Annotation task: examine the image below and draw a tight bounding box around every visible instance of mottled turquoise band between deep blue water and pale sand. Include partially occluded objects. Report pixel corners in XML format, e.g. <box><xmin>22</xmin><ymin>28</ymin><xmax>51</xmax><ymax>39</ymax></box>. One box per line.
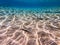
<box><xmin>0</xmin><ymin>6</ymin><xmax>60</xmax><ymax>15</ymax></box>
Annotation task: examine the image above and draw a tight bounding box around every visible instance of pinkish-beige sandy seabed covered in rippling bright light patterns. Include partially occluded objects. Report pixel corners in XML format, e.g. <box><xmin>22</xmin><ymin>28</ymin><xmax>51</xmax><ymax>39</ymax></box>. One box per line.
<box><xmin>0</xmin><ymin>7</ymin><xmax>60</xmax><ymax>45</ymax></box>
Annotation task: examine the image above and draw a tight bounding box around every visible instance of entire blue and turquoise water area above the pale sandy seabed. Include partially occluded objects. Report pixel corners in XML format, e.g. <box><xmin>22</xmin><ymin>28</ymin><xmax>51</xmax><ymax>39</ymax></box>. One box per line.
<box><xmin>0</xmin><ymin>0</ymin><xmax>60</xmax><ymax>13</ymax></box>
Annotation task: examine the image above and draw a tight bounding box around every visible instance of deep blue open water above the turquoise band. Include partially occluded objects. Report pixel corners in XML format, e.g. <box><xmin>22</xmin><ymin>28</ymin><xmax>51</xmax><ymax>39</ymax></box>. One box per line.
<box><xmin>0</xmin><ymin>0</ymin><xmax>60</xmax><ymax>8</ymax></box>
